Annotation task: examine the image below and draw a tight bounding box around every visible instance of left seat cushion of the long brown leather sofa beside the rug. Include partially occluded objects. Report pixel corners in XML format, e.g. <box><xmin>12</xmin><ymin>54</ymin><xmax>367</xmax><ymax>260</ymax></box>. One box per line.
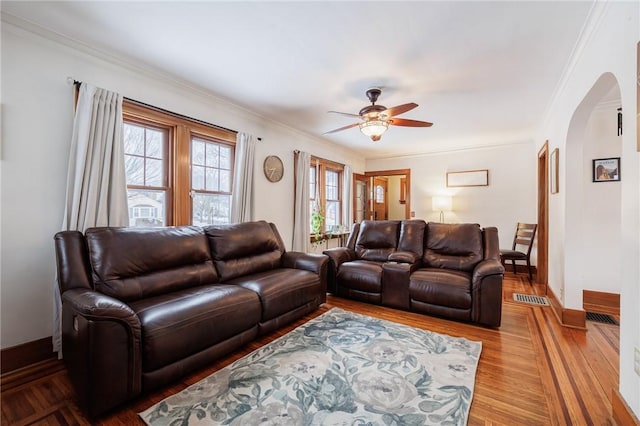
<box><xmin>130</xmin><ymin>284</ymin><xmax>261</xmax><ymax>372</ymax></box>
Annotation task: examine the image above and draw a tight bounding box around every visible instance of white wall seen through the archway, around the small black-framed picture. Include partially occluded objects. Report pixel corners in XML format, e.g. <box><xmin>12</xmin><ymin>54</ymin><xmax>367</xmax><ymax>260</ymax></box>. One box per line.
<box><xmin>564</xmin><ymin>73</ymin><xmax>624</xmax><ymax>309</ymax></box>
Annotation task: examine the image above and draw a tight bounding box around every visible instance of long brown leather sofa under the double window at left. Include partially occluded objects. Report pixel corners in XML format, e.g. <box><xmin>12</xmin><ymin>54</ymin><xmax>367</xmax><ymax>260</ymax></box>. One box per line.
<box><xmin>55</xmin><ymin>221</ymin><xmax>328</xmax><ymax>418</ymax></box>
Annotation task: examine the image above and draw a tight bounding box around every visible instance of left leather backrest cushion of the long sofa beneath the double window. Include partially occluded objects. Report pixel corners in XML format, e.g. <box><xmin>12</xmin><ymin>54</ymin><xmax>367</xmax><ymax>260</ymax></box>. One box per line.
<box><xmin>85</xmin><ymin>226</ymin><xmax>218</xmax><ymax>301</ymax></box>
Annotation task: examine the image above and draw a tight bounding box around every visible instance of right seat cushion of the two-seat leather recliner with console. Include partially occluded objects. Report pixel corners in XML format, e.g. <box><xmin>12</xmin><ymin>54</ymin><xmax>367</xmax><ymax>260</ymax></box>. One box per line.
<box><xmin>409</xmin><ymin>268</ymin><xmax>471</xmax><ymax>309</ymax></box>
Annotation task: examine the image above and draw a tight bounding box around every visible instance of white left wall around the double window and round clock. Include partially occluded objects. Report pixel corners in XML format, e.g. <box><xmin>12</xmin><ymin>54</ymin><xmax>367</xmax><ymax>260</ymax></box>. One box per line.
<box><xmin>0</xmin><ymin>17</ymin><xmax>364</xmax><ymax>348</ymax></box>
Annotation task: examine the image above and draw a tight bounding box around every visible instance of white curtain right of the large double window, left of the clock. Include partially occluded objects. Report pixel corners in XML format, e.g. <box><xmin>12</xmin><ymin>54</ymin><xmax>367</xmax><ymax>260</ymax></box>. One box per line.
<box><xmin>231</xmin><ymin>132</ymin><xmax>256</xmax><ymax>223</ymax></box>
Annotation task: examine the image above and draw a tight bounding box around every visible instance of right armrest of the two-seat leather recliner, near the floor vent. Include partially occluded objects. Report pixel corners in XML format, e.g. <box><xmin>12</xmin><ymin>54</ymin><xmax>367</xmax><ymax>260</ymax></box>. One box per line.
<box><xmin>471</xmin><ymin>259</ymin><xmax>504</xmax><ymax>327</ymax></box>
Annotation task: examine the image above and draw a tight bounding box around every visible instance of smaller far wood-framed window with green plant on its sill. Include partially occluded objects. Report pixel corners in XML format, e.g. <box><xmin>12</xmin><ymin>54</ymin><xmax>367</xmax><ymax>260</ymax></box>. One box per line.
<box><xmin>309</xmin><ymin>158</ymin><xmax>344</xmax><ymax>232</ymax></box>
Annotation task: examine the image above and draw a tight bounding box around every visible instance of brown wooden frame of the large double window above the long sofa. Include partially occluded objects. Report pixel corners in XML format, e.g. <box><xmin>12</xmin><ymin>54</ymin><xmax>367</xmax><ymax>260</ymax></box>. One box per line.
<box><xmin>122</xmin><ymin>99</ymin><xmax>237</xmax><ymax>226</ymax></box>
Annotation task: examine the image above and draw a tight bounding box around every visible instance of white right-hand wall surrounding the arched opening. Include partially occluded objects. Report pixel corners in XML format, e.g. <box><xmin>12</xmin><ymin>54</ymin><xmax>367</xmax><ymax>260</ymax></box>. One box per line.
<box><xmin>531</xmin><ymin>2</ymin><xmax>640</xmax><ymax>417</ymax></box>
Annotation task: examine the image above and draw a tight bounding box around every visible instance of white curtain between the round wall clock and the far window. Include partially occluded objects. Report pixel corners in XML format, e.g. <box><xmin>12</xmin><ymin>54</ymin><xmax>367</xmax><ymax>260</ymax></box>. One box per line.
<box><xmin>291</xmin><ymin>151</ymin><xmax>311</xmax><ymax>252</ymax></box>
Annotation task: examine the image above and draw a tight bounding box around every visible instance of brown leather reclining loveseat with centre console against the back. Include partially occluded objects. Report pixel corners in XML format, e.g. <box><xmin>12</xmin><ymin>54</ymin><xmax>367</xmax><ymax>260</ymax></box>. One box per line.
<box><xmin>324</xmin><ymin>220</ymin><xmax>504</xmax><ymax>327</ymax></box>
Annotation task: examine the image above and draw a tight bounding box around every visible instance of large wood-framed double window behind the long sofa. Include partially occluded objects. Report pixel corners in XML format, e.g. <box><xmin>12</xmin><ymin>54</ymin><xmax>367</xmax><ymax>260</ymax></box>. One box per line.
<box><xmin>123</xmin><ymin>100</ymin><xmax>236</xmax><ymax>226</ymax></box>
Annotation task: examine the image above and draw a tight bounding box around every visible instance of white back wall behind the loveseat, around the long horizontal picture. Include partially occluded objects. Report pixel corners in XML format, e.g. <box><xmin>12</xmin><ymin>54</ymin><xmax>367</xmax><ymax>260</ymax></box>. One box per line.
<box><xmin>366</xmin><ymin>142</ymin><xmax>537</xmax><ymax>256</ymax></box>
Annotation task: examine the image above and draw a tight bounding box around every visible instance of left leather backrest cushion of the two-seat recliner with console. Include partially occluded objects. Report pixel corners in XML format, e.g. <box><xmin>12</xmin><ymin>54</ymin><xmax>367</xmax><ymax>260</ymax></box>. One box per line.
<box><xmin>355</xmin><ymin>220</ymin><xmax>400</xmax><ymax>262</ymax></box>
